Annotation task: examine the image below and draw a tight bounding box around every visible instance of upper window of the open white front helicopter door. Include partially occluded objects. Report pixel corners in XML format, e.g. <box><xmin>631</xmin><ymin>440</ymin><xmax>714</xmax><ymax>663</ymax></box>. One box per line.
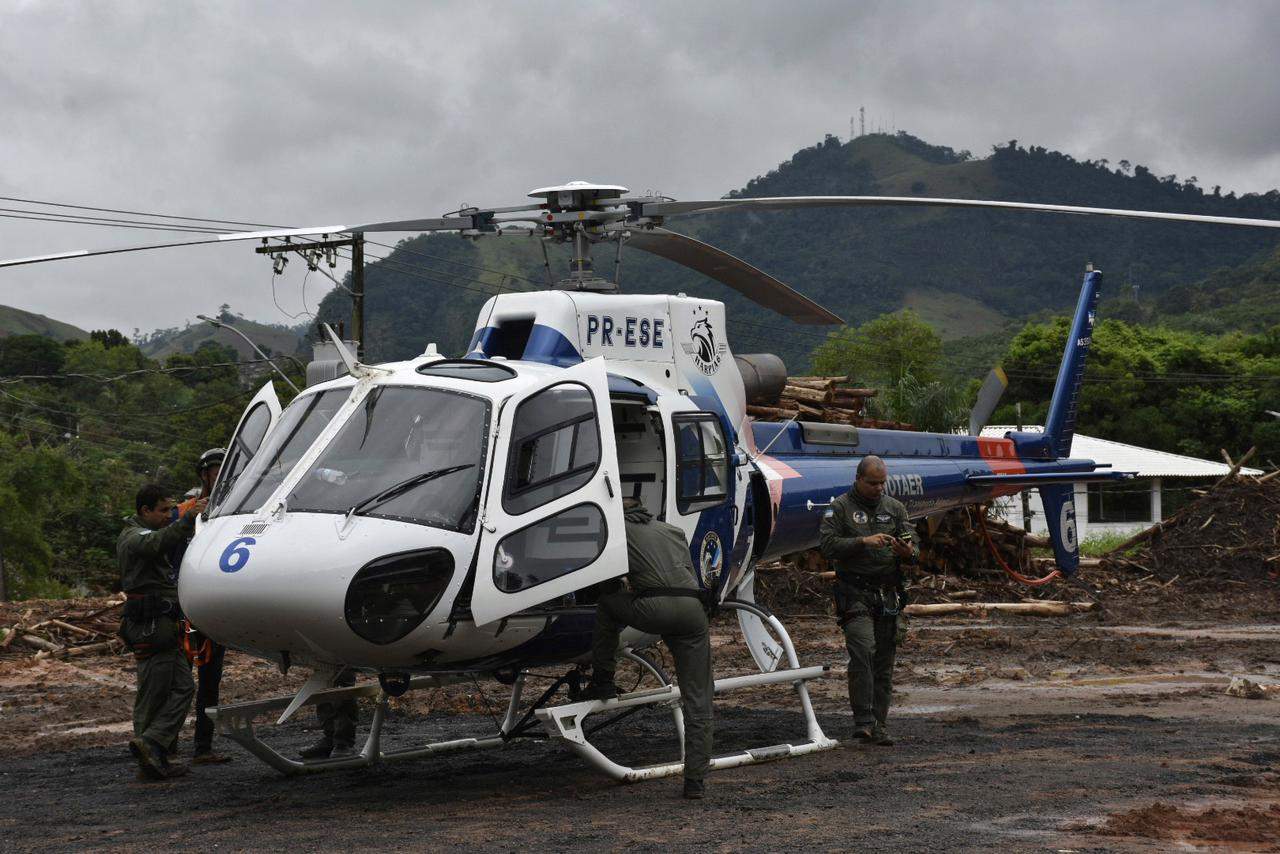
<box><xmin>502</xmin><ymin>383</ymin><xmax>600</xmax><ymax>516</ymax></box>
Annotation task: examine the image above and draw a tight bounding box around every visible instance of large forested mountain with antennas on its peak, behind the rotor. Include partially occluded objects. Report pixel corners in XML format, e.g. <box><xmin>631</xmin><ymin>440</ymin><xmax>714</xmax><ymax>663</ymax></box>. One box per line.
<box><xmin>312</xmin><ymin>133</ymin><xmax>1280</xmax><ymax>371</ymax></box>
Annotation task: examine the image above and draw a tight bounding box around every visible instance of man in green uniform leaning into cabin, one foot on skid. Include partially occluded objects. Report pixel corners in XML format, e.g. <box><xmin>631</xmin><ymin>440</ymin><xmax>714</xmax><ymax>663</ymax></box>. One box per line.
<box><xmin>581</xmin><ymin>498</ymin><xmax>714</xmax><ymax>799</ymax></box>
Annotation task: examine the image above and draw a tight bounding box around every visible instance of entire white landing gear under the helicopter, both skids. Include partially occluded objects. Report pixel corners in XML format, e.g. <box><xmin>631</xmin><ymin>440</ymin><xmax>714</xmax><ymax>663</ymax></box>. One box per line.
<box><xmin>209</xmin><ymin>600</ymin><xmax>837</xmax><ymax>782</ymax></box>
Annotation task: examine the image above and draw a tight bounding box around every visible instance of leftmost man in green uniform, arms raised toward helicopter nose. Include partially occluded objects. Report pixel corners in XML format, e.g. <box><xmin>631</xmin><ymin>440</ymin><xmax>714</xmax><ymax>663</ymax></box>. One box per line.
<box><xmin>115</xmin><ymin>484</ymin><xmax>206</xmax><ymax>780</ymax></box>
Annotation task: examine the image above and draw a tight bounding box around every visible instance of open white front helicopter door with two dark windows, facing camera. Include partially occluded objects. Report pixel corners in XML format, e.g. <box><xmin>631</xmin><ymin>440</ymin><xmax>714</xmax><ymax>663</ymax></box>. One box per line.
<box><xmin>471</xmin><ymin>359</ymin><xmax>627</xmax><ymax>625</ymax></box>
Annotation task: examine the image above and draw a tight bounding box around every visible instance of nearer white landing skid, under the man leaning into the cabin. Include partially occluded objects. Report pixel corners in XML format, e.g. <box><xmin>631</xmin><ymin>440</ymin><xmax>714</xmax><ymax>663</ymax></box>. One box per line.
<box><xmin>535</xmin><ymin>599</ymin><xmax>840</xmax><ymax>782</ymax></box>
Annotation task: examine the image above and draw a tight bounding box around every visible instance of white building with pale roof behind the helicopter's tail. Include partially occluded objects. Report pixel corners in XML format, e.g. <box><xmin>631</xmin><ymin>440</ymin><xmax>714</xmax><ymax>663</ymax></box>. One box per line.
<box><xmin>982</xmin><ymin>426</ymin><xmax>1262</xmax><ymax>540</ymax></box>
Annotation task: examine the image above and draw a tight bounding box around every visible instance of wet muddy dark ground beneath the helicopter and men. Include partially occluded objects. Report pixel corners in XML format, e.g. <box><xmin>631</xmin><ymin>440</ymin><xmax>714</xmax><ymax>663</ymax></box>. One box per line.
<box><xmin>0</xmin><ymin>593</ymin><xmax>1280</xmax><ymax>851</ymax></box>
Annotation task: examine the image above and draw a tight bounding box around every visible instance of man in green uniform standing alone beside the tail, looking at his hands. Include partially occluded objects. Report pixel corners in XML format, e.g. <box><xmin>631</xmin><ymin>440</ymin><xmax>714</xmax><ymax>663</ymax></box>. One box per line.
<box><xmin>819</xmin><ymin>456</ymin><xmax>918</xmax><ymax>746</ymax></box>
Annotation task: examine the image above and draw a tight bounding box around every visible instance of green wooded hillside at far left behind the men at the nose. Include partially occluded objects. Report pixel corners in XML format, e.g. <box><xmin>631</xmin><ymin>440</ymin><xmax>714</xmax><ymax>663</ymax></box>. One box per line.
<box><xmin>0</xmin><ymin>329</ymin><xmax>289</xmax><ymax>598</ymax></box>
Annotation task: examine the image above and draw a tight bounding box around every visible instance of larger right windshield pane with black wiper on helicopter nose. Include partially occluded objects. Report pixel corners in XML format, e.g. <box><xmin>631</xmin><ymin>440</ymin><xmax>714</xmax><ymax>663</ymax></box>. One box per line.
<box><xmin>288</xmin><ymin>385</ymin><xmax>489</xmax><ymax>531</ymax></box>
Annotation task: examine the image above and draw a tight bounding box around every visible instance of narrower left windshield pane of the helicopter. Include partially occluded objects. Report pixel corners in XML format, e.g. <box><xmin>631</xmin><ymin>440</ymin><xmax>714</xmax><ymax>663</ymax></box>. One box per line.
<box><xmin>214</xmin><ymin>388</ymin><xmax>351</xmax><ymax>516</ymax></box>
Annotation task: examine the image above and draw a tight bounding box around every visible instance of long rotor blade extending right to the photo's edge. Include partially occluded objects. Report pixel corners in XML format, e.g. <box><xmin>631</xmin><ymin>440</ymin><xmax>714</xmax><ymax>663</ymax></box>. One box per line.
<box><xmin>643</xmin><ymin>196</ymin><xmax>1280</xmax><ymax>228</ymax></box>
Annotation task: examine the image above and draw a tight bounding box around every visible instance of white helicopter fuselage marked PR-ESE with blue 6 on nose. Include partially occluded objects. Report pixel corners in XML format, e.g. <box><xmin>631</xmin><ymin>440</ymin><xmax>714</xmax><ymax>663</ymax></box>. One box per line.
<box><xmin>179</xmin><ymin>291</ymin><xmax>755</xmax><ymax>672</ymax></box>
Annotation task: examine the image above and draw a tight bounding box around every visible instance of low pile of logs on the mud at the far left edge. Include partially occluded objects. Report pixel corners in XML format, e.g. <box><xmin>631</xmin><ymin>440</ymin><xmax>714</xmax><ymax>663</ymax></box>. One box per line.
<box><xmin>0</xmin><ymin>594</ymin><xmax>124</xmax><ymax>658</ymax></box>
